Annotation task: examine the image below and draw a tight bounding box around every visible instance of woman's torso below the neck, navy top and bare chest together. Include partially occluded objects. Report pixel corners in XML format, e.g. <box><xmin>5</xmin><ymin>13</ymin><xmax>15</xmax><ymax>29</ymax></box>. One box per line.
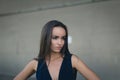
<box><xmin>36</xmin><ymin>53</ymin><xmax>77</xmax><ymax>80</ymax></box>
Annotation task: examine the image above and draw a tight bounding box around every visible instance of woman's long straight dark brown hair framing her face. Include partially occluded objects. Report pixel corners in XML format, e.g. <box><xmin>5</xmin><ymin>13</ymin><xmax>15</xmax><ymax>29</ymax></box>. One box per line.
<box><xmin>38</xmin><ymin>20</ymin><xmax>69</xmax><ymax>59</ymax></box>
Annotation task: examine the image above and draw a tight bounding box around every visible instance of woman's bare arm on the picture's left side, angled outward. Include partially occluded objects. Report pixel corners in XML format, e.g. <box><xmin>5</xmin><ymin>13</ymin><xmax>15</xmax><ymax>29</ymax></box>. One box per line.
<box><xmin>14</xmin><ymin>60</ymin><xmax>38</xmax><ymax>80</ymax></box>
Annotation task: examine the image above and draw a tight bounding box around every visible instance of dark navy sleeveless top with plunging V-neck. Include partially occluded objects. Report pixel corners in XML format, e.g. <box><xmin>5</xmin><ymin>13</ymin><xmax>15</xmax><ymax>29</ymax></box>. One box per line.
<box><xmin>36</xmin><ymin>54</ymin><xmax>77</xmax><ymax>80</ymax></box>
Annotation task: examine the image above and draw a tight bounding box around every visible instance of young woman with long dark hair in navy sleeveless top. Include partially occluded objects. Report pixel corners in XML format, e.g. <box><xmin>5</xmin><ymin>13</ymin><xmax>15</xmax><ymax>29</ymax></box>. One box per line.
<box><xmin>14</xmin><ymin>20</ymin><xmax>100</xmax><ymax>80</ymax></box>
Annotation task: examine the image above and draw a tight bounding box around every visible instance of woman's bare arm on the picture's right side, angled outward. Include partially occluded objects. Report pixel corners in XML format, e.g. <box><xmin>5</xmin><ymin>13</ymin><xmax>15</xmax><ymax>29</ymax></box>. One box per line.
<box><xmin>72</xmin><ymin>55</ymin><xmax>100</xmax><ymax>80</ymax></box>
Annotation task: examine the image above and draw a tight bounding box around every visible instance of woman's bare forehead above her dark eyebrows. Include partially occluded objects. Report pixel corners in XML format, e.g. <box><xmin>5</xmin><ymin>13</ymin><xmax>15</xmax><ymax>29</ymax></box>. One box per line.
<box><xmin>52</xmin><ymin>26</ymin><xmax>66</xmax><ymax>36</ymax></box>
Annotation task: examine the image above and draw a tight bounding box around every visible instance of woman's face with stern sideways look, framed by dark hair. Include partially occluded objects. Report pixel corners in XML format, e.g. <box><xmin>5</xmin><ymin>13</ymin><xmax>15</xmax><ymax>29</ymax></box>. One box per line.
<box><xmin>51</xmin><ymin>26</ymin><xmax>66</xmax><ymax>53</ymax></box>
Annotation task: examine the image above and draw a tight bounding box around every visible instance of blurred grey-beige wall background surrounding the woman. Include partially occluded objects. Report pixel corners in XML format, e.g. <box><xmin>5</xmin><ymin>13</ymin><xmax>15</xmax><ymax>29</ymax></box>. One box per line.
<box><xmin>0</xmin><ymin>0</ymin><xmax>120</xmax><ymax>80</ymax></box>
